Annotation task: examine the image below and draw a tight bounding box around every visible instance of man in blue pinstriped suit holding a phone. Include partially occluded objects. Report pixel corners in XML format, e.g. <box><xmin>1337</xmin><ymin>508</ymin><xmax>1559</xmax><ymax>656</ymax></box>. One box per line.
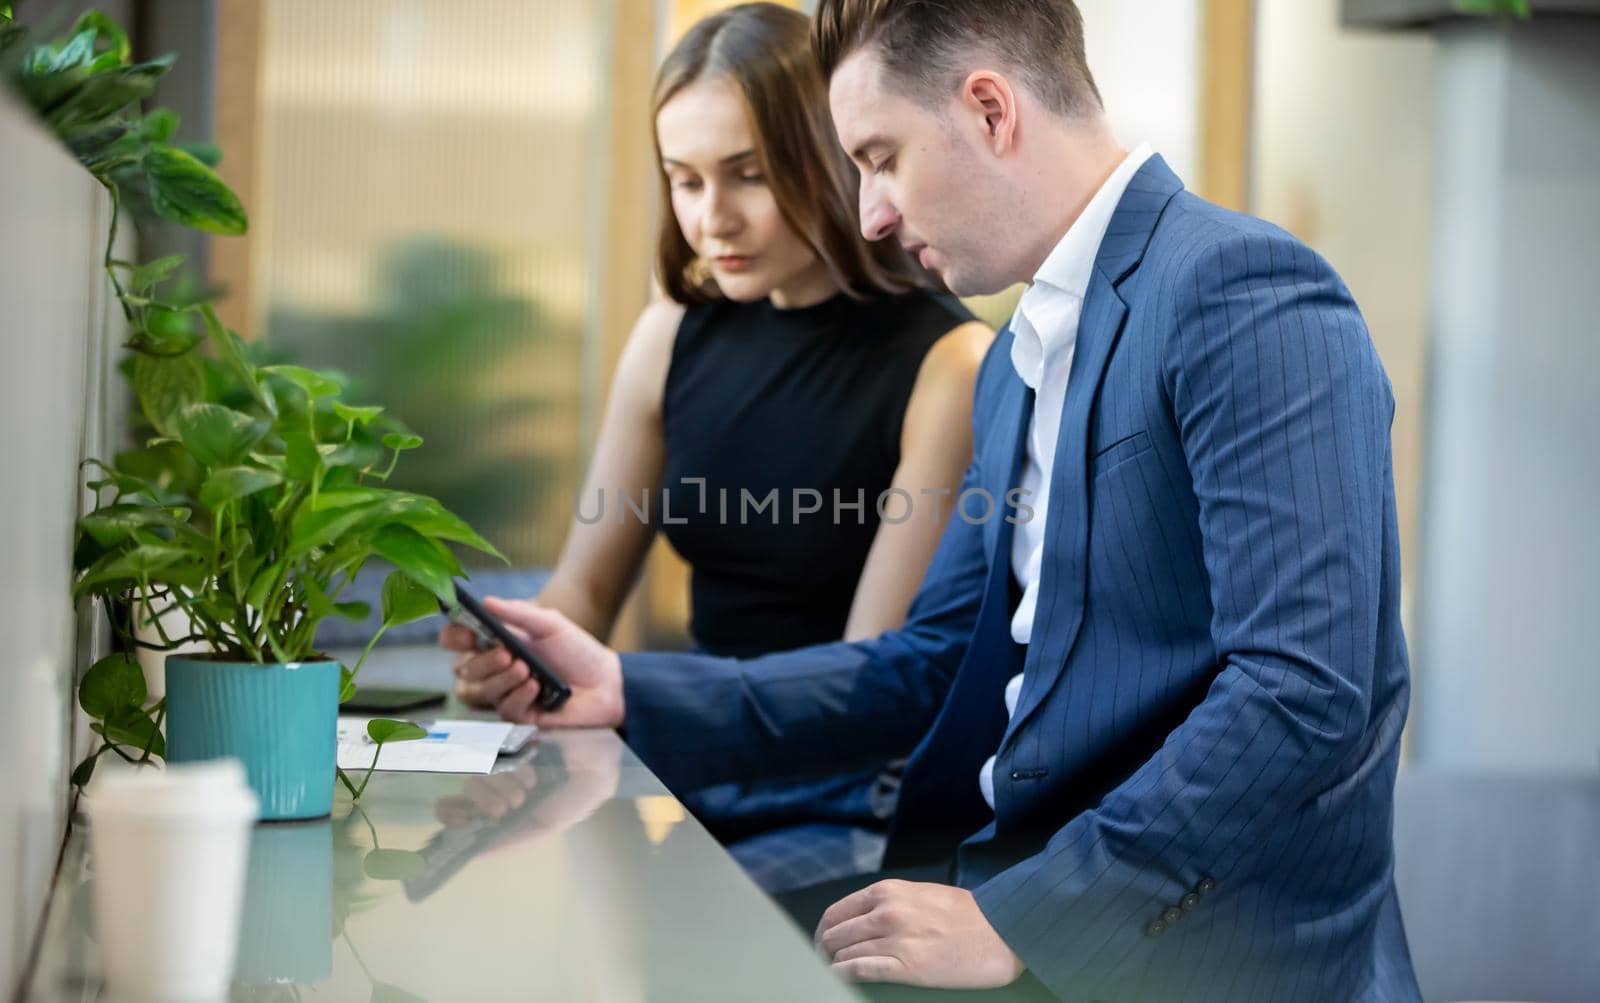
<box><xmin>451</xmin><ymin>0</ymin><xmax>1418</xmax><ymax>1003</ymax></box>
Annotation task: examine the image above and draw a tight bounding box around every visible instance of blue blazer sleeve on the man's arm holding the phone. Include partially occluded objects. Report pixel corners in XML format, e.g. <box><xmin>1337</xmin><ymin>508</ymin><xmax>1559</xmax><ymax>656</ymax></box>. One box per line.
<box><xmin>622</xmin><ymin>338</ymin><xmax>1010</xmax><ymax>790</ymax></box>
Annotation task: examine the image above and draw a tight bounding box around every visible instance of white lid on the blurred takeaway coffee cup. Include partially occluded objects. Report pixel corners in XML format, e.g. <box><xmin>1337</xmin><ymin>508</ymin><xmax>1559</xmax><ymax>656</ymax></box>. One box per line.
<box><xmin>83</xmin><ymin>760</ymin><xmax>261</xmax><ymax>822</ymax></box>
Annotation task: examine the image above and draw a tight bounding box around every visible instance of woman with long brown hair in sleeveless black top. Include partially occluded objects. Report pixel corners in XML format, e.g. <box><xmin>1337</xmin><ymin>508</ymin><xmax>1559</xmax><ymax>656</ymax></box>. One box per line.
<box><xmin>442</xmin><ymin>3</ymin><xmax>992</xmax><ymax>891</ymax></box>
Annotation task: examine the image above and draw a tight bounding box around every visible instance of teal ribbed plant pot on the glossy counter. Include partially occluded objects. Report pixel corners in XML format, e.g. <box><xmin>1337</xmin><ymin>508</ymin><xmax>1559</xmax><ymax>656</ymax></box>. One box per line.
<box><xmin>166</xmin><ymin>656</ymin><xmax>339</xmax><ymax>822</ymax></box>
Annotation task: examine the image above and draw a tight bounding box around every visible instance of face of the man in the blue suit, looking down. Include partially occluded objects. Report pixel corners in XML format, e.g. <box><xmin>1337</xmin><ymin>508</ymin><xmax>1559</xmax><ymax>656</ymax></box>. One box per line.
<box><xmin>829</xmin><ymin>46</ymin><xmax>1014</xmax><ymax>296</ymax></box>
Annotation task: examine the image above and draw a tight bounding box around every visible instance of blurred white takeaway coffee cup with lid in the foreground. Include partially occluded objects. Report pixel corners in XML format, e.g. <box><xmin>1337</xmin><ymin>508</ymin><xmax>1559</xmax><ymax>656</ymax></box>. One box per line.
<box><xmin>83</xmin><ymin>760</ymin><xmax>261</xmax><ymax>1000</ymax></box>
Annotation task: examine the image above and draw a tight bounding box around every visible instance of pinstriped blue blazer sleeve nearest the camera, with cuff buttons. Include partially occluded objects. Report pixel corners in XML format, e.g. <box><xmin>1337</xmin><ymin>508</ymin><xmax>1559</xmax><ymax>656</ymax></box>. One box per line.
<box><xmin>974</xmin><ymin>227</ymin><xmax>1394</xmax><ymax>995</ymax></box>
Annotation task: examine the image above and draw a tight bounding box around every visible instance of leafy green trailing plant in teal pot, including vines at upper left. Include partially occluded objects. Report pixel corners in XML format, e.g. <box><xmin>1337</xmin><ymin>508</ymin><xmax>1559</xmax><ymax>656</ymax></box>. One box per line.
<box><xmin>0</xmin><ymin>3</ymin><xmax>498</xmax><ymax>819</ymax></box>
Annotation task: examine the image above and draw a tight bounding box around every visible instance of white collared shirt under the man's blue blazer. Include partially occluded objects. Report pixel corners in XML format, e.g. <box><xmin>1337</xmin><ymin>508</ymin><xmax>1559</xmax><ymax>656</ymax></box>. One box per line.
<box><xmin>978</xmin><ymin>144</ymin><xmax>1152</xmax><ymax>808</ymax></box>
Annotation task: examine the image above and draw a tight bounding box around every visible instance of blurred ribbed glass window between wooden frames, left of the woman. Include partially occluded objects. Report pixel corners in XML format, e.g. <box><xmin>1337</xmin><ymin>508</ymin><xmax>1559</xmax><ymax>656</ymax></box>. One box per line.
<box><xmin>253</xmin><ymin>0</ymin><xmax>614</xmax><ymax>566</ymax></box>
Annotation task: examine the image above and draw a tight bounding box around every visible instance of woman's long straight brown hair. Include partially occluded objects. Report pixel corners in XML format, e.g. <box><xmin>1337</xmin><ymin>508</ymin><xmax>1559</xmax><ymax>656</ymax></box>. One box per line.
<box><xmin>654</xmin><ymin>3</ymin><xmax>938</xmax><ymax>304</ymax></box>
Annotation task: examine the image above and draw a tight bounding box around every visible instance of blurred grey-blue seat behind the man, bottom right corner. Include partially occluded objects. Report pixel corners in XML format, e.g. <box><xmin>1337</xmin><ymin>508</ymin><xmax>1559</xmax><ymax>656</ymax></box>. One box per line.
<box><xmin>1395</xmin><ymin>769</ymin><xmax>1600</xmax><ymax>1003</ymax></box>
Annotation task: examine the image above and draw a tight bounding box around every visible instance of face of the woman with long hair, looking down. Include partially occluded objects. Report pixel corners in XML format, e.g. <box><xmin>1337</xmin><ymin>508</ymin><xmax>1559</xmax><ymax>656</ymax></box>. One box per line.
<box><xmin>656</xmin><ymin>77</ymin><xmax>837</xmax><ymax>307</ymax></box>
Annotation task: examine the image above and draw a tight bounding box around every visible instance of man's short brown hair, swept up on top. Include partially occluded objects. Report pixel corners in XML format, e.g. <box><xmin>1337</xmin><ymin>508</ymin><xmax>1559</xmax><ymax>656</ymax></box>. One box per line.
<box><xmin>811</xmin><ymin>0</ymin><xmax>1101</xmax><ymax>118</ymax></box>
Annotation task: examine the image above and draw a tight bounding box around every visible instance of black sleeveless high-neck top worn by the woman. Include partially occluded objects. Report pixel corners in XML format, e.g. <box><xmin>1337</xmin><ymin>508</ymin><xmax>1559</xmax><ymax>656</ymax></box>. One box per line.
<box><xmin>656</xmin><ymin>293</ymin><xmax>973</xmax><ymax>657</ymax></box>
